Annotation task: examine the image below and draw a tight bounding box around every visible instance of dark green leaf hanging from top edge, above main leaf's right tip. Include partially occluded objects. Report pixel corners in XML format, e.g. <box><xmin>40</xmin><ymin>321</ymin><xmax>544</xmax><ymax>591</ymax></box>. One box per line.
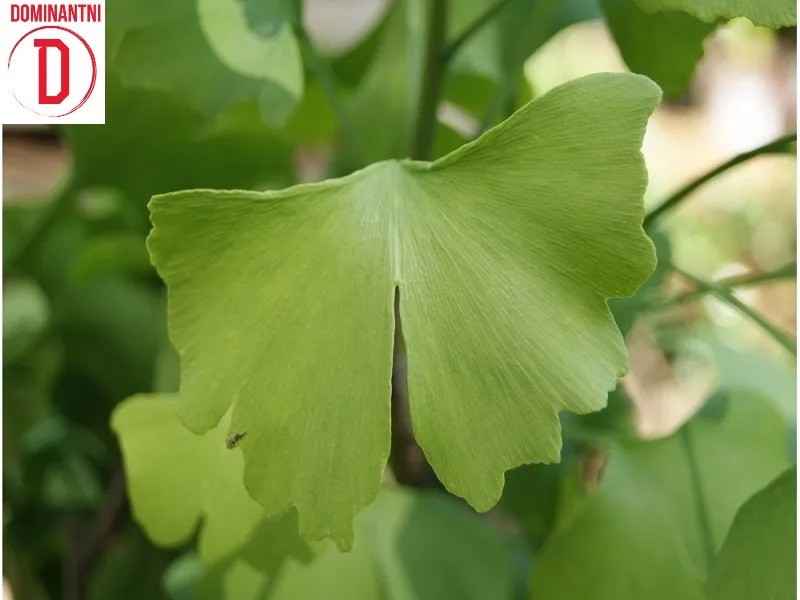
<box><xmin>603</xmin><ymin>0</ymin><xmax>714</xmax><ymax>96</ymax></box>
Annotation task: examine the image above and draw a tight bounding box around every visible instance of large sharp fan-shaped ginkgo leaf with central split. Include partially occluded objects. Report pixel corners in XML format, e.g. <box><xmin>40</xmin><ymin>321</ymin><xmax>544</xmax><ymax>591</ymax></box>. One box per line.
<box><xmin>148</xmin><ymin>74</ymin><xmax>660</xmax><ymax>547</ymax></box>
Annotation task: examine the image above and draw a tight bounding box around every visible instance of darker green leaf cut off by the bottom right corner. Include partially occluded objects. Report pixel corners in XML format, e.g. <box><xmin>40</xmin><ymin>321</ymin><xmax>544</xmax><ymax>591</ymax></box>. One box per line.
<box><xmin>708</xmin><ymin>468</ymin><xmax>797</xmax><ymax>600</ymax></box>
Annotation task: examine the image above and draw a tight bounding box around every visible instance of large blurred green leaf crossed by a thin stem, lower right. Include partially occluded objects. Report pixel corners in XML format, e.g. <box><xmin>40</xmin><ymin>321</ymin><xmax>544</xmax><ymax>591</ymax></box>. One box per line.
<box><xmin>532</xmin><ymin>395</ymin><xmax>788</xmax><ymax>600</ymax></box>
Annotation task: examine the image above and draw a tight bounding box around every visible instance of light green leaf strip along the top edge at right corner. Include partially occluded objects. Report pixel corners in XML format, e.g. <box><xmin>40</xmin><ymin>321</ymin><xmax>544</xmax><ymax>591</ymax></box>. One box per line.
<box><xmin>636</xmin><ymin>0</ymin><xmax>797</xmax><ymax>28</ymax></box>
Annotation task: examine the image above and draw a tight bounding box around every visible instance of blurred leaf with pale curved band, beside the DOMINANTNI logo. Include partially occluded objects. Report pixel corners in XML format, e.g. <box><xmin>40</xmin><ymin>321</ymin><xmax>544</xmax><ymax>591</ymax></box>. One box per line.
<box><xmin>108</xmin><ymin>0</ymin><xmax>303</xmax><ymax>123</ymax></box>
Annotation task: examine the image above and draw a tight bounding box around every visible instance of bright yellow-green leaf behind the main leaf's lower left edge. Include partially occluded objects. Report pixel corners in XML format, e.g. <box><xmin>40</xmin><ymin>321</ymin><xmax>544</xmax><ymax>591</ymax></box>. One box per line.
<box><xmin>112</xmin><ymin>394</ymin><xmax>309</xmax><ymax>571</ymax></box>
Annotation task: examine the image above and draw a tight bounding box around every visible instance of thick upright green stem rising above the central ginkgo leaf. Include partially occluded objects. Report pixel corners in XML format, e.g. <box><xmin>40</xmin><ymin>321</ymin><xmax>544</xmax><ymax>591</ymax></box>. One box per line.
<box><xmin>411</xmin><ymin>0</ymin><xmax>447</xmax><ymax>160</ymax></box>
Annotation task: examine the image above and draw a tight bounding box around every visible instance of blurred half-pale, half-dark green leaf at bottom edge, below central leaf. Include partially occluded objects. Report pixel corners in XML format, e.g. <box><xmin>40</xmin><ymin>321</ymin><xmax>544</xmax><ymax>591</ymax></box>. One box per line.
<box><xmin>269</xmin><ymin>490</ymin><xmax>512</xmax><ymax>600</ymax></box>
